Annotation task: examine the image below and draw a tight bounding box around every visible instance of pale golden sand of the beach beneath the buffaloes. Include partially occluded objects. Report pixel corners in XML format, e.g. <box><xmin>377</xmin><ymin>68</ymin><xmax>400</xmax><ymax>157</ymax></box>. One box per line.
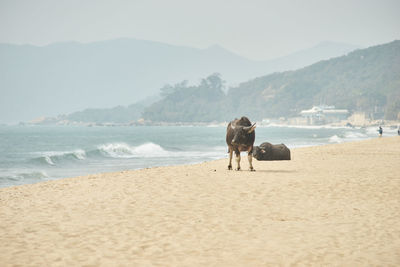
<box><xmin>0</xmin><ymin>137</ymin><xmax>400</xmax><ymax>266</ymax></box>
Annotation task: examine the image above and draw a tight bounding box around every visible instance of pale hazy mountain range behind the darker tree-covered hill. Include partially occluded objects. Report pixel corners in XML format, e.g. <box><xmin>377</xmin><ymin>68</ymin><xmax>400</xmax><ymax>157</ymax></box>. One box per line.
<box><xmin>0</xmin><ymin>39</ymin><xmax>356</xmax><ymax>123</ymax></box>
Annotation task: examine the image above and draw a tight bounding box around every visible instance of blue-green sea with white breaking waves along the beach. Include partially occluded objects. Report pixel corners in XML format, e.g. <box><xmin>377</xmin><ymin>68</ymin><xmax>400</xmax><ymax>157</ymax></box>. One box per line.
<box><xmin>0</xmin><ymin>126</ymin><xmax>396</xmax><ymax>187</ymax></box>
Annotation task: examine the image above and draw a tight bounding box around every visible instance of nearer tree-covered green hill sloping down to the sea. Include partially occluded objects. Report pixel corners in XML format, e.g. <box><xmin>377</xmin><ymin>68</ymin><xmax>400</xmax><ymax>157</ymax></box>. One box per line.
<box><xmin>144</xmin><ymin>41</ymin><xmax>400</xmax><ymax>122</ymax></box>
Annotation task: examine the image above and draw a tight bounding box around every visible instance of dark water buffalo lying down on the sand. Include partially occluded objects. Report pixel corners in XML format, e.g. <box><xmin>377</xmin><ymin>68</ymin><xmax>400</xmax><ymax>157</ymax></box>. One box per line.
<box><xmin>253</xmin><ymin>142</ymin><xmax>290</xmax><ymax>160</ymax></box>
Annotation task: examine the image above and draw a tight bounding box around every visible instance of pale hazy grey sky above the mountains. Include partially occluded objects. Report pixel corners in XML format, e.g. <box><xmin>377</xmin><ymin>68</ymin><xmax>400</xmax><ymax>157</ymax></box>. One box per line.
<box><xmin>0</xmin><ymin>0</ymin><xmax>400</xmax><ymax>60</ymax></box>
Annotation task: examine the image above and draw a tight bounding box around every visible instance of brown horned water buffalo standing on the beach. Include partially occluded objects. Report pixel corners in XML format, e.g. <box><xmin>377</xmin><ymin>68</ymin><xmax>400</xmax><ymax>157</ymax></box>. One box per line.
<box><xmin>226</xmin><ymin>117</ymin><xmax>256</xmax><ymax>171</ymax></box>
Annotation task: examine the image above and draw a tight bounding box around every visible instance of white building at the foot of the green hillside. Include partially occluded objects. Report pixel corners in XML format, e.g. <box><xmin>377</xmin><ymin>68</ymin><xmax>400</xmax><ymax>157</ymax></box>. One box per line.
<box><xmin>300</xmin><ymin>105</ymin><xmax>349</xmax><ymax>125</ymax></box>
